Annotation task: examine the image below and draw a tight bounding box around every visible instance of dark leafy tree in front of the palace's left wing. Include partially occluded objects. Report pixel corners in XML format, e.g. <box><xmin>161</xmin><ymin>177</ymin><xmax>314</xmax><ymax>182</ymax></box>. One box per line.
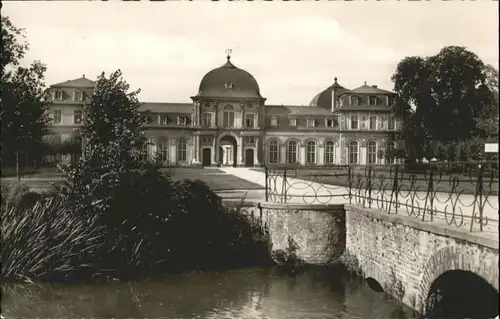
<box><xmin>61</xmin><ymin>70</ymin><xmax>144</xmax><ymax>208</ymax></box>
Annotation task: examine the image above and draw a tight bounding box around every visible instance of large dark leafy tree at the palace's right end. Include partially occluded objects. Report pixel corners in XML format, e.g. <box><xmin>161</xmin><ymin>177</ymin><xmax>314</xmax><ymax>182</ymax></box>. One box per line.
<box><xmin>392</xmin><ymin>46</ymin><xmax>498</xmax><ymax>158</ymax></box>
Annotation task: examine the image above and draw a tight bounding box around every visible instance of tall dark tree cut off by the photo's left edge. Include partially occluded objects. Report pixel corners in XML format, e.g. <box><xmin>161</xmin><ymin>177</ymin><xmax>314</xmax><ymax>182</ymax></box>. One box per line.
<box><xmin>0</xmin><ymin>16</ymin><xmax>48</xmax><ymax>180</ymax></box>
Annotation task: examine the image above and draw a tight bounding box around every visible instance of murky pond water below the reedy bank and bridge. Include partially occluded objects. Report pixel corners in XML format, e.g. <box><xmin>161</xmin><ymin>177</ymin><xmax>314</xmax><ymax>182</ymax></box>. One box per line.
<box><xmin>2</xmin><ymin>268</ymin><xmax>412</xmax><ymax>319</ymax></box>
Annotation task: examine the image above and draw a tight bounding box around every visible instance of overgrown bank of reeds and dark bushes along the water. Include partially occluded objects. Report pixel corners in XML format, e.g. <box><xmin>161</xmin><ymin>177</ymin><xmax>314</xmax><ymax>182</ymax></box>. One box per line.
<box><xmin>0</xmin><ymin>175</ymin><xmax>270</xmax><ymax>282</ymax></box>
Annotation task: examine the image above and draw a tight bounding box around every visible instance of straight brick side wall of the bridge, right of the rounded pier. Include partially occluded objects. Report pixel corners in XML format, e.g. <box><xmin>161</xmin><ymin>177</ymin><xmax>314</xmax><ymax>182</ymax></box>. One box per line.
<box><xmin>345</xmin><ymin>205</ymin><xmax>499</xmax><ymax>310</ymax></box>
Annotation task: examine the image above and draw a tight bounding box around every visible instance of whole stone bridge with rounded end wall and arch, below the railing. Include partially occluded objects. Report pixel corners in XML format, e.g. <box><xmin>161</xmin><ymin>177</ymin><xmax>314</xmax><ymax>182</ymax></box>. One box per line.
<box><xmin>235</xmin><ymin>202</ymin><xmax>499</xmax><ymax>312</ymax></box>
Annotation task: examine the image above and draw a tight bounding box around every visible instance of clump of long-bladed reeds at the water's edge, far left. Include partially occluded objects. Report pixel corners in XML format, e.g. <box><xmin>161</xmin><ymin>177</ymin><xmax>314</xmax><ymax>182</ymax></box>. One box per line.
<box><xmin>0</xmin><ymin>190</ymin><xmax>102</xmax><ymax>282</ymax></box>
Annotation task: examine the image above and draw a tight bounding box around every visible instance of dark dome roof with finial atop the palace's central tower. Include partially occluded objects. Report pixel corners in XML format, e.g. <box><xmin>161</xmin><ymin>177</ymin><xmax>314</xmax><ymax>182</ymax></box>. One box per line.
<box><xmin>196</xmin><ymin>56</ymin><xmax>262</xmax><ymax>99</ymax></box>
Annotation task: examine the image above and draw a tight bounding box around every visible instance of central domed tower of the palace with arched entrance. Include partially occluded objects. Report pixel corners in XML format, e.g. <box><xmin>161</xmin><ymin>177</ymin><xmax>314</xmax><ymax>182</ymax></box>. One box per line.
<box><xmin>191</xmin><ymin>50</ymin><xmax>266</xmax><ymax>166</ymax></box>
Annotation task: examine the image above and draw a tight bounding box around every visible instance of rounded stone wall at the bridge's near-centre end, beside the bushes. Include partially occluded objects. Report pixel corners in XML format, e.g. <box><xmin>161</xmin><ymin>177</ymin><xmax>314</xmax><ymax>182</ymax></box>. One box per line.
<box><xmin>235</xmin><ymin>203</ymin><xmax>345</xmax><ymax>265</ymax></box>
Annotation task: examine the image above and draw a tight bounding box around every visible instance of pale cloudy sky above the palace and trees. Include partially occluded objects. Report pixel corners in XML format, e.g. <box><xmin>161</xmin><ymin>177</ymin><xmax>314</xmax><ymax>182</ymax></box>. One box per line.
<box><xmin>2</xmin><ymin>0</ymin><xmax>499</xmax><ymax>105</ymax></box>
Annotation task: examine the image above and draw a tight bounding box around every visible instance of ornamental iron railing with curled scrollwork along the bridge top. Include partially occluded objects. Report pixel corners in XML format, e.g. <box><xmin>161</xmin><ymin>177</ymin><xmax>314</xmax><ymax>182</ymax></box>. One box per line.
<box><xmin>265</xmin><ymin>162</ymin><xmax>499</xmax><ymax>232</ymax></box>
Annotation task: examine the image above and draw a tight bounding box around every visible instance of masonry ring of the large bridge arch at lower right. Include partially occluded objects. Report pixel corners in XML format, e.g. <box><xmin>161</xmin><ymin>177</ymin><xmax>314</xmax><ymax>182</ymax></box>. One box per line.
<box><xmin>418</xmin><ymin>246</ymin><xmax>499</xmax><ymax>312</ymax></box>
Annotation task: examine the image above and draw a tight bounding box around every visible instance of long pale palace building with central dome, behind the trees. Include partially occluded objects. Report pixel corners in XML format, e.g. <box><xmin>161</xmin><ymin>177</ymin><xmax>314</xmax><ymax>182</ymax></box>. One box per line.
<box><xmin>44</xmin><ymin>56</ymin><xmax>401</xmax><ymax>167</ymax></box>
